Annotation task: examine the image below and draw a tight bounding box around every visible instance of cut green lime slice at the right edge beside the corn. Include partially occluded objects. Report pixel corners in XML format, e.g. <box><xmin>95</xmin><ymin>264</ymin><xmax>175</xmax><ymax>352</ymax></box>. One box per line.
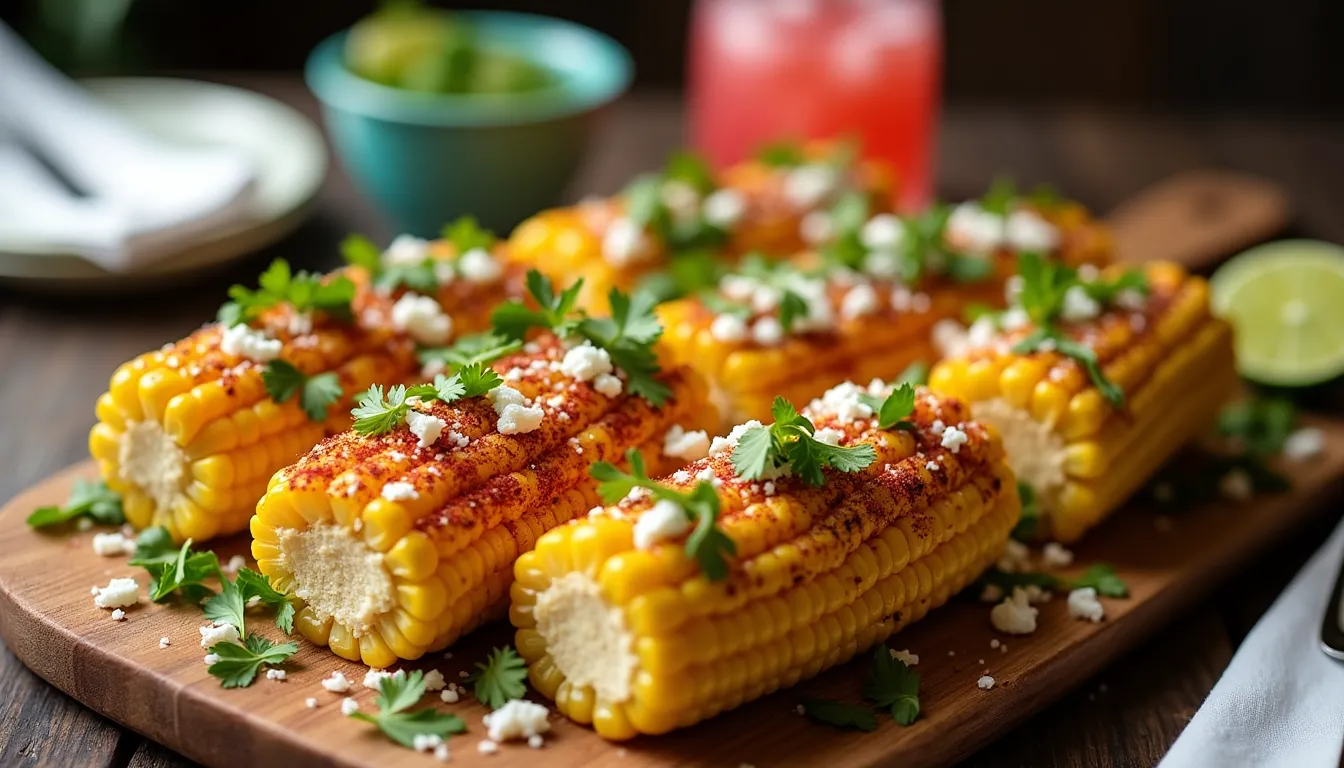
<box><xmin>1210</xmin><ymin>239</ymin><xmax>1344</xmax><ymax>386</ymax></box>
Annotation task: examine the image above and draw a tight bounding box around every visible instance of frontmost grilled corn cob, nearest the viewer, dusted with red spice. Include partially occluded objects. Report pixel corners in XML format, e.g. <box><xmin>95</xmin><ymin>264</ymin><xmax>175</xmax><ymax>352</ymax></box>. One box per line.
<box><xmin>509</xmin><ymin>382</ymin><xmax>1020</xmax><ymax>740</ymax></box>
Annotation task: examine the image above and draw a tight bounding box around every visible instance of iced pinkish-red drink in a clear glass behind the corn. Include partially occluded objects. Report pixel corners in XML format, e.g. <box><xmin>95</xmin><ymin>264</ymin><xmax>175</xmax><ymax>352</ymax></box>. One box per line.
<box><xmin>689</xmin><ymin>0</ymin><xmax>942</xmax><ymax>210</ymax></box>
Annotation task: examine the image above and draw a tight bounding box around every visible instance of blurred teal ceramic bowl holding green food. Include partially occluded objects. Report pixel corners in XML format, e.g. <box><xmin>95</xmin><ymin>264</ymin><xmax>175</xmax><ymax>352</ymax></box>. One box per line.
<box><xmin>305</xmin><ymin>11</ymin><xmax>633</xmax><ymax>237</ymax></box>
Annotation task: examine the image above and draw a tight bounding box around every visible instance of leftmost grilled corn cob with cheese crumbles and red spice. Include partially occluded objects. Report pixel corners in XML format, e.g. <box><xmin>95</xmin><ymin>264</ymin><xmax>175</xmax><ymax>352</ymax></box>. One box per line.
<box><xmin>89</xmin><ymin>238</ymin><xmax>521</xmax><ymax>542</ymax></box>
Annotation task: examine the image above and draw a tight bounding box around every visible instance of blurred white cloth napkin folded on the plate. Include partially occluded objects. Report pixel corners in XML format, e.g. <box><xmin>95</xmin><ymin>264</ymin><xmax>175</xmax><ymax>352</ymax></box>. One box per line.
<box><xmin>0</xmin><ymin>23</ymin><xmax>255</xmax><ymax>272</ymax></box>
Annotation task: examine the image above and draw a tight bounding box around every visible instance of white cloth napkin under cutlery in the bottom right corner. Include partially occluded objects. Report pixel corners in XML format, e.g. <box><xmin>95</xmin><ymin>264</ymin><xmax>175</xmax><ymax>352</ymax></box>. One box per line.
<box><xmin>1159</xmin><ymin>523</ymin><xmax>1344</xmax><ymax>768</ymax></box>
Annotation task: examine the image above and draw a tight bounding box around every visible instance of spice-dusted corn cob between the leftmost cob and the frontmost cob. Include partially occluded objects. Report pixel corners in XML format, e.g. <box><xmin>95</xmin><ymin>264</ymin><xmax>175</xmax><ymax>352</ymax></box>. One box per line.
<box><xmin>251</xmin><ymin>335</ymin><xmax>715</xmax><ymax>667</ymax></box>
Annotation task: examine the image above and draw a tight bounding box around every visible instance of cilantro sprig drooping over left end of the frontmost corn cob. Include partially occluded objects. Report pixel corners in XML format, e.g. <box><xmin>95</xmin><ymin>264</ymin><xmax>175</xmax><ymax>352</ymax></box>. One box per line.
<box><xmin>589</xmin><ymin>448</ymin><xmax>738</xmax><ymax>581</ymax></box>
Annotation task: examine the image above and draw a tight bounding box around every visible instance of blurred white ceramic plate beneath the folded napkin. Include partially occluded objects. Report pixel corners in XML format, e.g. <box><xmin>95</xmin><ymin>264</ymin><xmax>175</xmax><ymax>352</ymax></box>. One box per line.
<box><xmin>0</xmin><ymin>78</ymin><xmax>327</xmax><ymax>291</ymax></box>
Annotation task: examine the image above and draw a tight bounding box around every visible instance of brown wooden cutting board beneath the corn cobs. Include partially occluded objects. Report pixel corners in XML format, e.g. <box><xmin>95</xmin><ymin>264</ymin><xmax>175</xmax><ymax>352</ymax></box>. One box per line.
<box><xmin>0</xmin><ymin>420</ymin><xmax>1344</xmax><ymax>768</ymax></box>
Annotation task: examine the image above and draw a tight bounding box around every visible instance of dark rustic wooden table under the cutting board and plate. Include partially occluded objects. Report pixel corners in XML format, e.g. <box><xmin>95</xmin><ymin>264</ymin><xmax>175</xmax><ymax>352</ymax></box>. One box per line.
<box><xmin>0</xmin><ymin>75</ymin><xmax>1344</xmax><ymax>768</ymax></box>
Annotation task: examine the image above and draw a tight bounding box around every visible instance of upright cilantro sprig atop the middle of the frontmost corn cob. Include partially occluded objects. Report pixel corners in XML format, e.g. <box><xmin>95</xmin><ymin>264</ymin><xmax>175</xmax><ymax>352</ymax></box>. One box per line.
<box><xmin>732</xmin><ymin>397</ymin><xmax>878</xmax><ymax>486</ymax></box>
